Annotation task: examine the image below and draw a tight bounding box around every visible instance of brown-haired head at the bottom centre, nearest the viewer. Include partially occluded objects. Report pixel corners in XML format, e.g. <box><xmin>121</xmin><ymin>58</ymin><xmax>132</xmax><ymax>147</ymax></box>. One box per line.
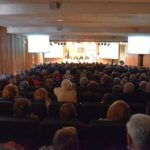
<box><xmin>53</xmin><ymin>127</ymin><xmax>78</xmax><ymax>150</ymax></box>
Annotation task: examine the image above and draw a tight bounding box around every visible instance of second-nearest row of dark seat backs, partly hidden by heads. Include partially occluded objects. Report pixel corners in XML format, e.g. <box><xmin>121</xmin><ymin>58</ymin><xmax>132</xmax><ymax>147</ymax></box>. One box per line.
<box><xmin>0</xmin><ymin>100</ymin><xmax>146</xmax><ymax>123</ymax></box>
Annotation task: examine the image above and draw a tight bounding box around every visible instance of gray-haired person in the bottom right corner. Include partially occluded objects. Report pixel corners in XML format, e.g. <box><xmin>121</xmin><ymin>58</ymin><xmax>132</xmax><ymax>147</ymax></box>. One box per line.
<box><xmin>127</xmin><ymin>114</ymin><xmax>150</xmax><ymax>150</ymax></box>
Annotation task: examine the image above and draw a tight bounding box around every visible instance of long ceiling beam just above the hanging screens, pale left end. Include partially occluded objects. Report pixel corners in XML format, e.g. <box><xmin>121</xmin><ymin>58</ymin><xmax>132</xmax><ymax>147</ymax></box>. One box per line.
<box><xmin>7</xmin><ymin>26</ymin><xmax>150</xmax><ymax>35</ymax></box>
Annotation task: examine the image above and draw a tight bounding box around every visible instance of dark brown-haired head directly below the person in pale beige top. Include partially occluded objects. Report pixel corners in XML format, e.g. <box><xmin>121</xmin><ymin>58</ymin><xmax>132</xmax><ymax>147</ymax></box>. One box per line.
<box><xmin>60</xmin><ymin>103</ymin><xmax>77</xmax><ymax>120</ymax></box>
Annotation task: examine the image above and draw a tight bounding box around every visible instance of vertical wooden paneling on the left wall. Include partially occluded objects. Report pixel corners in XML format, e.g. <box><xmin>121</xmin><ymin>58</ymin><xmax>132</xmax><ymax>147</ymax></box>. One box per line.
<box><xmin>0</xmin><ymin>27</ymin><xmax>30</xmax><ymax>75</ymax></box>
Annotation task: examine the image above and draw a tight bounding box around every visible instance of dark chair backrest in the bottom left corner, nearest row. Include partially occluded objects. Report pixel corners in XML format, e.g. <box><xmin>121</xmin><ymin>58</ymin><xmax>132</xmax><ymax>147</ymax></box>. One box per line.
<box><xmin>0</xmin><ymin>117</ymin><xmax>40</xmax><ymax>149</ymax></box>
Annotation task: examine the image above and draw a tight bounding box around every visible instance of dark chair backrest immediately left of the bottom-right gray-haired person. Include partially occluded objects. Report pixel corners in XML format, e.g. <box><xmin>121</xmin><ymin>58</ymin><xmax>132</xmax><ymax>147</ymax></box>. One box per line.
<box><xmin>86</xmin><ymin>120</ymin><xmax>126</xmax><ymax>150</ymax></box>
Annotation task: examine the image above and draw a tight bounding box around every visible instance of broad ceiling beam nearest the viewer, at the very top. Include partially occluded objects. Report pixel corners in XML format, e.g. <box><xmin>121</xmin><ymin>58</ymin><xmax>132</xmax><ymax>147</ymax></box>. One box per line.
<box><xmin>0</xmin><ymin>2</ymin><xmax>150</xmax><ymax>15</ymax></box>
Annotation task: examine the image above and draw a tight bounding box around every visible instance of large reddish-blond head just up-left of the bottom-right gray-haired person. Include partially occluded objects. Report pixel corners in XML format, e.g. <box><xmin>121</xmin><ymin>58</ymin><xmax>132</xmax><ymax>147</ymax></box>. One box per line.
<box><xmin>107</xmin><ymin>100</ymin><xmax>130</xmax><ymax>122</ymax></box>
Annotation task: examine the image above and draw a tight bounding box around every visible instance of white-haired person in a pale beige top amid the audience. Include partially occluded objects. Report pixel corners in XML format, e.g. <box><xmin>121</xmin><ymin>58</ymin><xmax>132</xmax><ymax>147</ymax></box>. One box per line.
<box><xmin>54</xmin><ymin>79</ymin><xmax>77</xmax><ymax>103</ymax></box>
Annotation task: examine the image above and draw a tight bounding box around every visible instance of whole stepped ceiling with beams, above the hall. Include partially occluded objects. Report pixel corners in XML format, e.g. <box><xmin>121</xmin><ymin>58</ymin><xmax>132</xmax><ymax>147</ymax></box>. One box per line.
<box><xmin>0</xmin><ymin>0</ymin><xmax>150</xmax><ymax>41</ymax></box>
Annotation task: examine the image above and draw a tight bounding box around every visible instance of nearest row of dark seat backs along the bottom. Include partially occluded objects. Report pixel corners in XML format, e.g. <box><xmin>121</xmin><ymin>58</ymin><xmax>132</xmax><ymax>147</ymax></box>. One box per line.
<box><xmin>0</xmin><ymin>117</ymin><xmax>126</xmax><ymax>150</ymax></box>
